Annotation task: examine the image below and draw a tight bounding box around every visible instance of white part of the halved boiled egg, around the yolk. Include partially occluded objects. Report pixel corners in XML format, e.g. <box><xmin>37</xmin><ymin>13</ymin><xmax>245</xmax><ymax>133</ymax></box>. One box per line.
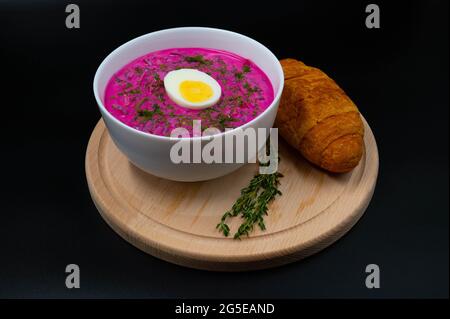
<box><xmin>164</xmin><ymin>69</ymin><xmax>222</xmax><ymax>110</ymax></box>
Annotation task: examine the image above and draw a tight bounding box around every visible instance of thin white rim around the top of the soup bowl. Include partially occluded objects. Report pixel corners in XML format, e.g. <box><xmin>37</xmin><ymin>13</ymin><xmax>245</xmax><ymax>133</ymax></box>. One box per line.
<box><xmin>93</xmin><ymin>27</ymin><xmax>284</xmax><ymax>141</ymax></box>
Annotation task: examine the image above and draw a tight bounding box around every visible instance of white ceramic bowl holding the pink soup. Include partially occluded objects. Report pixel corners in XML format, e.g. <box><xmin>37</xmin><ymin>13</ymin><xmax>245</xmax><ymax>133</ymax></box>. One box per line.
<box><xmin>94</xmin><ymin>27</ymin><xmax>284</xmax><ymax>181</ymax></box>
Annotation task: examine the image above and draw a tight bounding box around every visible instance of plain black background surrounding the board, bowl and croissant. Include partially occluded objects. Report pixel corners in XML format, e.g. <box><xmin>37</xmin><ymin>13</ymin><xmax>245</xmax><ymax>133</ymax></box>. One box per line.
<box><xmin>0</xmin><ymin>0</ymin><xmax>449</xmax><ymax>298</ymax></box>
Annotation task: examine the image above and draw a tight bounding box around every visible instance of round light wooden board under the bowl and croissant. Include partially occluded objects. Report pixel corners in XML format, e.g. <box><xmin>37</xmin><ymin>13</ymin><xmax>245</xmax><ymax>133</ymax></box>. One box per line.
<box><xmin>86</xmin><ymin>116</ymin><xmax>378</xmax><ymax>271</ymax></box>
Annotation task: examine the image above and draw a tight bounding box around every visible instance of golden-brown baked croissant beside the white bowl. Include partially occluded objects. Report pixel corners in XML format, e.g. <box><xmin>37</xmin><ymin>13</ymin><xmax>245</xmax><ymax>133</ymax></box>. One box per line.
<box><xmin>275</xmin><ymin>59</ymin><xmax>364</xmax><ymax>173</ymax></box>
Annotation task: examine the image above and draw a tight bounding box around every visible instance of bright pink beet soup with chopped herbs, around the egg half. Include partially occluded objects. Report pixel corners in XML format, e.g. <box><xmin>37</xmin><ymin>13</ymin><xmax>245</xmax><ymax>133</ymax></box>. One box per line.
<box><xmin>105</xmin><ymin>48</ymin><xmax>274</xmax><ymax>136</ymax></box>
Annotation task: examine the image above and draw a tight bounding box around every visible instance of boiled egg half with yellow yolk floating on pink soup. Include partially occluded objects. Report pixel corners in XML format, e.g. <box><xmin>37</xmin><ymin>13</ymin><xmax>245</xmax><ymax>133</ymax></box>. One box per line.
<box><xmin>164</xmin><ymin>69</ymin><xmax>222</xmax><ymax>110</ymax></box>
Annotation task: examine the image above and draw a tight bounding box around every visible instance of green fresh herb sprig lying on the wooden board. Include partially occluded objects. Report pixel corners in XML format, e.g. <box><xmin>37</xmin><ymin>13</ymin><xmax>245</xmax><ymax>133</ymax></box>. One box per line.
<box><xmin>216</xmin><ymin>164</ymin><xmax>283</xmax><ymax>239</ymax></box>
